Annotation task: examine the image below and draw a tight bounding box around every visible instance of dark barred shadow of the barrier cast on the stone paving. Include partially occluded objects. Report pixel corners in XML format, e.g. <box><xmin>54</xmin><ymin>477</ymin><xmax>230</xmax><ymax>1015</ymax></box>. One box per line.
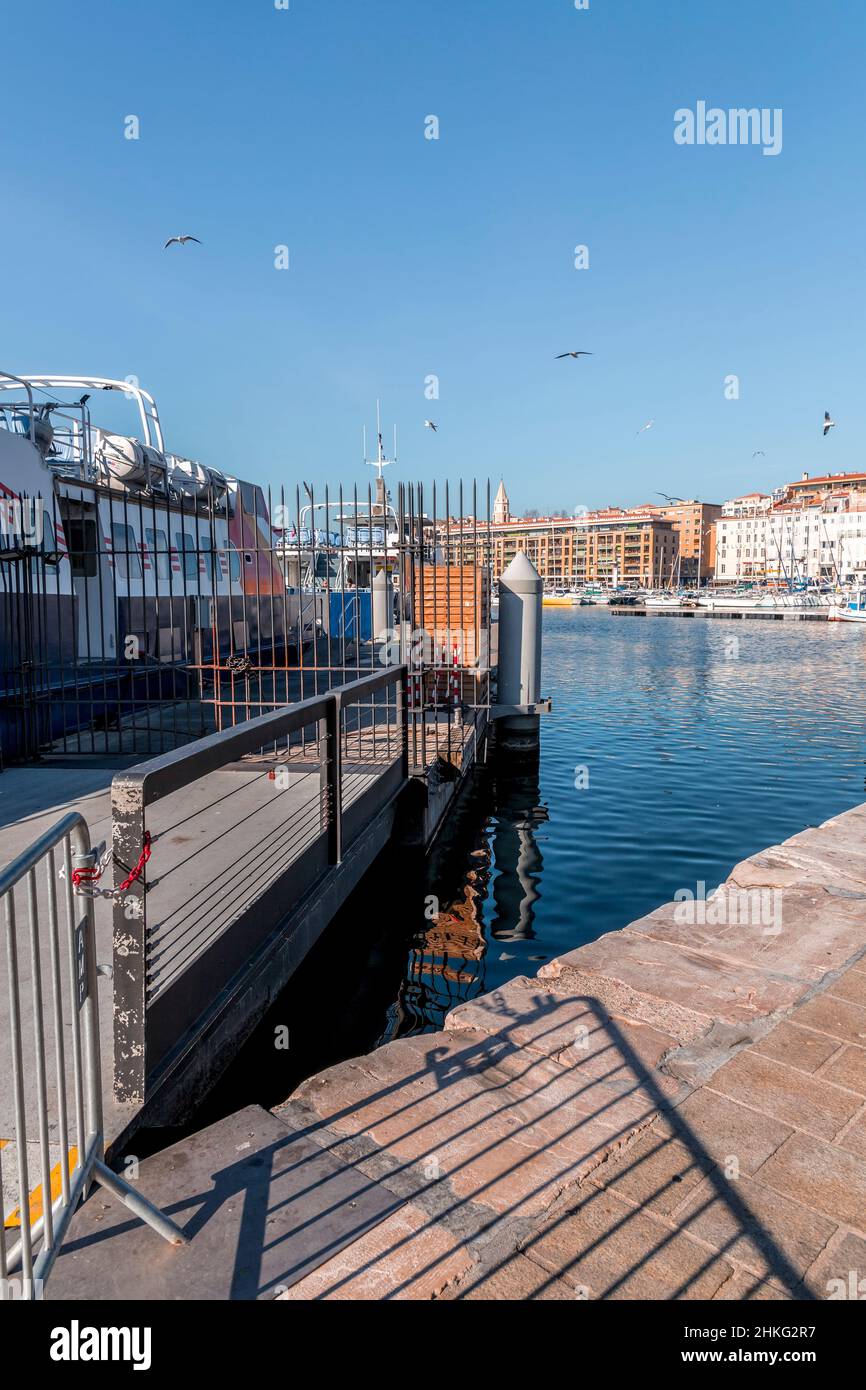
<box><xmin>54</xmin><ymin>995</ymin><xmax>815</xmax><ymax>1300</ymax></box>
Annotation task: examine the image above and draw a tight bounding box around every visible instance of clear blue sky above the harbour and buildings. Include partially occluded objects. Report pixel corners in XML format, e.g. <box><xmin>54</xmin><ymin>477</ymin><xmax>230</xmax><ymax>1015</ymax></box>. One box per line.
<box><xmin>0</xmin><ymin>0</ymin><xmax>866</xmax><ymax>510</ymax></box>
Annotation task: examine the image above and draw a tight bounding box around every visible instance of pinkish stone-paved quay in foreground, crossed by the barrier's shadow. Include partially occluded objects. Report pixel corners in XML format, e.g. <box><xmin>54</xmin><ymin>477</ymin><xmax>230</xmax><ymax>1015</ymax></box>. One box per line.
<box><xmin>49</xmin><ymin>805</ymin><xmax>866</xmax><ymax>1301</ymax></box>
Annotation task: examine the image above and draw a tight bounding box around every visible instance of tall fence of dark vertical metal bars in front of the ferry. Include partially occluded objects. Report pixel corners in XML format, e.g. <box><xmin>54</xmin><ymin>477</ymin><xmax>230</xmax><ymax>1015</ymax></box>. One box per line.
<box><xmin>0</xmin><ymin>461</ymin><xmax>495</xmax><ymax>767</ymax></box>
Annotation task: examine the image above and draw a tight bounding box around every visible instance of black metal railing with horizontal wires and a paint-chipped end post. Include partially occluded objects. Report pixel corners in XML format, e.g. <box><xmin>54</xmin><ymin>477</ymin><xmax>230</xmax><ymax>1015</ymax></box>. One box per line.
<box><xmin>111</xmin><ymin>666</ymin><xmax>409</xmax><ymax>1105</ymax></box>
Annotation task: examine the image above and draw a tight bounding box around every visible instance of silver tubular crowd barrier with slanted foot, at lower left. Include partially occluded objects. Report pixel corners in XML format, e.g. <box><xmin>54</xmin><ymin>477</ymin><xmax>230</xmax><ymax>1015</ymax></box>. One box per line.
<box><xmin>0</xmin><ymin>812</ymin><xmax>186</xmax><ymax>1301</ymax></box>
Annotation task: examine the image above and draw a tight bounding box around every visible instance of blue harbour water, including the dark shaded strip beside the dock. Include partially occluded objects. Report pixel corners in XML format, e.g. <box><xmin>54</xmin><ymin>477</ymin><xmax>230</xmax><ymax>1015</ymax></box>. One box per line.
<box><xmin>189</xmin><ymin>607</ymin><xmax>866</xmax><ymax>1104</ymax></box>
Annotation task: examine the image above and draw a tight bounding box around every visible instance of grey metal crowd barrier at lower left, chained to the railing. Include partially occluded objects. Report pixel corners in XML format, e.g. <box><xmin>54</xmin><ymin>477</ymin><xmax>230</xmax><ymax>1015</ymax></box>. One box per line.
<box><xmin>0</xmin><ymin>812</ymin><xmax>186</xmax><ymax>1301</ymax></box>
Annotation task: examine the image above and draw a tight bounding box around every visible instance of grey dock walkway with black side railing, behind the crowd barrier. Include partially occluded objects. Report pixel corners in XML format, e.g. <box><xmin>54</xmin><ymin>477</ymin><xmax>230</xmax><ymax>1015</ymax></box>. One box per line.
<box><xmin>0</xmin><ymin>669</ymin><xmax>488</xmax><ymax>1173</ymax></box>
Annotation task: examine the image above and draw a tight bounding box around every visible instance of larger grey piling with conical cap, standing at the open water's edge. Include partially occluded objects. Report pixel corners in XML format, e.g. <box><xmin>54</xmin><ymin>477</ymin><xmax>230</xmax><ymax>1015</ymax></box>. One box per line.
<box><xmin>496</xmin><ymin>550</ymin><xmax>544</xmax><ymax>752</ymax></box>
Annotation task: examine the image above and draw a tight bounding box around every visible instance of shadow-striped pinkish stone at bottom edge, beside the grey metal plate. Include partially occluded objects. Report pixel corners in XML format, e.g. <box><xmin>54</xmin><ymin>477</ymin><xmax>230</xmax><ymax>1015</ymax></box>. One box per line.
<box><xmin>277</xmin><ymin>1205</ymin><xmax>473</xmax><ymax>1302</ymax></box>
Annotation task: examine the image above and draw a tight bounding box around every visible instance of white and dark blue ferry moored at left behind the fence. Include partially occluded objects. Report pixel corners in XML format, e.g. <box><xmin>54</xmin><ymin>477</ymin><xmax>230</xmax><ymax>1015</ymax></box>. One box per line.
<box><xmin>0</xmin><ymin>373</ymin><xmax>321</xmax><ymax>760</ymax></box>
